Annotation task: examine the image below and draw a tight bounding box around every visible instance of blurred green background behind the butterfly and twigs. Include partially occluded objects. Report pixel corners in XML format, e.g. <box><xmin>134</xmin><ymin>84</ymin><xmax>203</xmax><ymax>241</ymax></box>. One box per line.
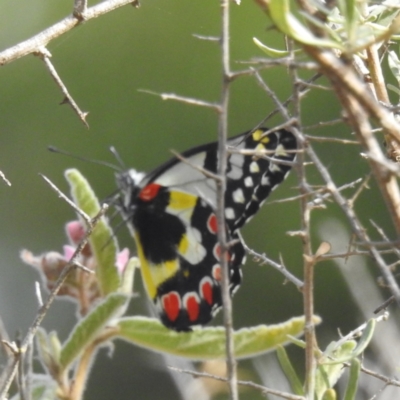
<box><xmin>0</xmin><ymin>0</ymin><xmax>398</xmax><ymax>400</ymax></box>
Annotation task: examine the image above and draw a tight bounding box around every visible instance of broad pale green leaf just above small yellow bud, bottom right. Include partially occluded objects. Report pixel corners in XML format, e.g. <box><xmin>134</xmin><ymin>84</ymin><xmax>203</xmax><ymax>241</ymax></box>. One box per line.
<box><xmin>315</xmin><ymin>340</ymin><xmax>357</xmax><ymax>400</ymax></box>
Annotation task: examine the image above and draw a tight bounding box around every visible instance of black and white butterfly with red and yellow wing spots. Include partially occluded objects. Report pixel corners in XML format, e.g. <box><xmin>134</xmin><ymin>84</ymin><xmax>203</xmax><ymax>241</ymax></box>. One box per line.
<box><xmin>117</xmin><ymin>128</ymin><xmax>297</xmax><ymax>331</ymax></box>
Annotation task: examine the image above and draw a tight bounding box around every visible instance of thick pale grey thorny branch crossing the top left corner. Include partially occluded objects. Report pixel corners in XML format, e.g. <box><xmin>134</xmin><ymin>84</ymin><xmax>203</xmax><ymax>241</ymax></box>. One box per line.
<box><xmin>0</xmin><ymin>0</ymin><xmax>138</xmax><ymax>66</ymax></box>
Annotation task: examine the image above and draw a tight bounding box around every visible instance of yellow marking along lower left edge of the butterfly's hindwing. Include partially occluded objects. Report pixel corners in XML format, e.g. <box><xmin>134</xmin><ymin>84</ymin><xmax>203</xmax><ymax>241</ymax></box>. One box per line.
<box><xmin>135</xmin><ymin>232</ymin><xmax>179</xmax><ymax>299</ymax></box>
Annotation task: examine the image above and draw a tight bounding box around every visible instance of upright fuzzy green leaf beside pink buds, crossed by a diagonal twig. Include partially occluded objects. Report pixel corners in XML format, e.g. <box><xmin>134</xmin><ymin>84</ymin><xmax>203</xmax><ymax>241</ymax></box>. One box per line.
<box><xmin>65</xmin><ymin>169</ymin><xmax>120</xmax><ymax>297</ymax></box>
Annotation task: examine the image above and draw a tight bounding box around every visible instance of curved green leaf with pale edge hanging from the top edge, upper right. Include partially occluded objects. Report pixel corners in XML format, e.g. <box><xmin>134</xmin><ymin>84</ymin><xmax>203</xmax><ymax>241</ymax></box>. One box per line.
<box><xmin>268</xmin><ymin>0</ymin><xmax>343</xmax><ymax>50</ymax></box>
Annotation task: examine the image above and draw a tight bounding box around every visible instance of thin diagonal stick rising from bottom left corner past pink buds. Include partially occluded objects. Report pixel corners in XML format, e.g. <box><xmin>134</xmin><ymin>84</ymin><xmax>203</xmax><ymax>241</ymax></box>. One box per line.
<box><xmin>0</xmin><ymin>180</ymin><xmax>104</xmax><ymax>399</ymax></box>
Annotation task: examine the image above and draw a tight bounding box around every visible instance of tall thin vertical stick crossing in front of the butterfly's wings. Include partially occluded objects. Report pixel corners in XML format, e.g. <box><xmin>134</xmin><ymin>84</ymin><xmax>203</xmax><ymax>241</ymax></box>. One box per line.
<box><xmin>216</xmin><ymin>0</ymin><xmax>239</xmax><ymax>400</ymax></box>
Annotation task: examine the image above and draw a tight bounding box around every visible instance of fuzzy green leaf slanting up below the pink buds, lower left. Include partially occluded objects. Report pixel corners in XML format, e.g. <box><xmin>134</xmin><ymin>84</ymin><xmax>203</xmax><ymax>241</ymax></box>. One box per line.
<box><xmin>60</xmin><ymin>293</ymin><xmax>129</xmax><ymax>370</ymax></box>
